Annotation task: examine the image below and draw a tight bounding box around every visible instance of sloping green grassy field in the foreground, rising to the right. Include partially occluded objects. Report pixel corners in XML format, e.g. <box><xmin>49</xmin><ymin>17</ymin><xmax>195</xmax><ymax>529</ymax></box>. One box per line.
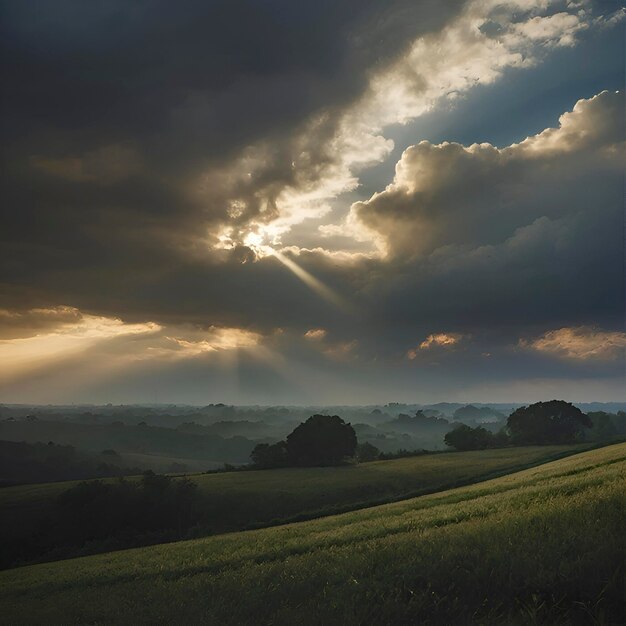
<box><xmin>0</xmin><ymin>444</ymin><xmax>626</xmax><ymax>624</ymax></box>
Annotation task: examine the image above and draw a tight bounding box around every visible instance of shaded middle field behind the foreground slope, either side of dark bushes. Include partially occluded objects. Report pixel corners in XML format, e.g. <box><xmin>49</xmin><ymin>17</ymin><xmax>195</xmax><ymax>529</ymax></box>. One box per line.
<box><xmin>0</xmin><ymin>446</ymin><xmax>582</xmax><ymax>567</ymax></box>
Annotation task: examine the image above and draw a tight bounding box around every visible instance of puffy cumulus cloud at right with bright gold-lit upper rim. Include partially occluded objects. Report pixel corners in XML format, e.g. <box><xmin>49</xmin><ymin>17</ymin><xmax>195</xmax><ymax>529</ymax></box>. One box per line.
<box><xmin>352</xmin><ymin>87</ymin><xmax>624</xmax><ymax>257</ymax></box>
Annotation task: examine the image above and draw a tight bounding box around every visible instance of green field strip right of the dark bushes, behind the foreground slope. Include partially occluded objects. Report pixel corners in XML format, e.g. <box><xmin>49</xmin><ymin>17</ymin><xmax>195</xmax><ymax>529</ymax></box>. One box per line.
<box><xmin>189</xmin><ymin>446</ymin><xmax>586</xmax><ymax>524</ymax></box>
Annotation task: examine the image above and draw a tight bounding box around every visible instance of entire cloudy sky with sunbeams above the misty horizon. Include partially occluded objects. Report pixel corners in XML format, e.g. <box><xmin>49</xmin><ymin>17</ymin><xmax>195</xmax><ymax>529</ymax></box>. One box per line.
<box><xmin>0</xmin><ymin>0</ymin><xmax>626</xmax><ymax>405</ymax></box>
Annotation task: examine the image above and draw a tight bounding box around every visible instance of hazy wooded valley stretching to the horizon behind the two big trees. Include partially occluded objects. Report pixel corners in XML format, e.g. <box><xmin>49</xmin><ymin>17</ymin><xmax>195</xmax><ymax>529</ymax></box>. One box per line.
<box><xmin>0</xmin><ymin>403</ymin><xmax>626</xmax><ymax>485</ymax></box>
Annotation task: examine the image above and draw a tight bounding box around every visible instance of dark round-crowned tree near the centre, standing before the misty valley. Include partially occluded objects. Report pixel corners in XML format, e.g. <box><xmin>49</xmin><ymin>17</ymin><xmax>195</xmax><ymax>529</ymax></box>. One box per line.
<box><xmin>287</xmin><ymin>415</ymin><xmax>357</xmax><ymax>466</ymax></box>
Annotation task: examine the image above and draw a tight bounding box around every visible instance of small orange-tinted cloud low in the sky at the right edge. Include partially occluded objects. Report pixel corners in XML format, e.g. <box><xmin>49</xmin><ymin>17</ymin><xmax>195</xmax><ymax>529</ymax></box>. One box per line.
<box><xmin>520</xmin><ymin>326</ymin><xmax>626</xmax><ymax>361</ymax></box>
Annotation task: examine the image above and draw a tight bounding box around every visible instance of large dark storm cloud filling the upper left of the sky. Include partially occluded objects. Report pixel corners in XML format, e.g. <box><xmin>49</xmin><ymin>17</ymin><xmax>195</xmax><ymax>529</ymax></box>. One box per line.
<box><xmin>0</xmin><ymin>0</ymin><xmax>460</xmax><ymax>315</ymax></box>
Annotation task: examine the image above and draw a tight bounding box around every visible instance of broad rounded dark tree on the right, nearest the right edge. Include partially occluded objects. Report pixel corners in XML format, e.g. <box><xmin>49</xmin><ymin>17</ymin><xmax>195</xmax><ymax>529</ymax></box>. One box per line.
<box><xmin>507</xmin><ymin>400</ymin><xmax>592</xmax><ymax>445</ymax></box>
